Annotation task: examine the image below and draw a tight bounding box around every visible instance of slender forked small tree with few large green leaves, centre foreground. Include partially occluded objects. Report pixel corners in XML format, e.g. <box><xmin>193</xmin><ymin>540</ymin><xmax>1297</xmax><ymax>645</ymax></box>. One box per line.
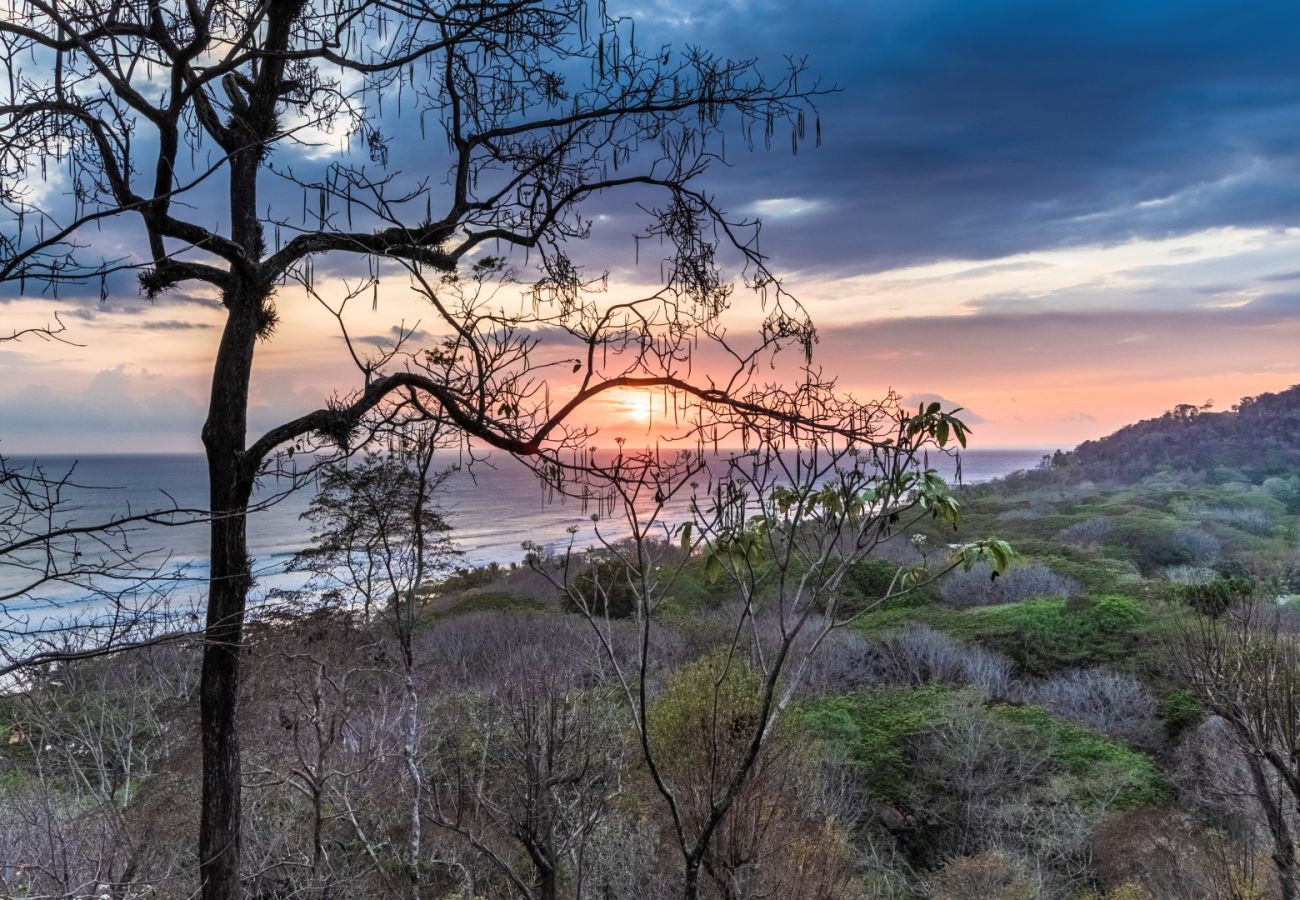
<box><xmin>530</xmin><ymin>423</ymin><xmax>1015</xmax><ymax>900</ymax></box>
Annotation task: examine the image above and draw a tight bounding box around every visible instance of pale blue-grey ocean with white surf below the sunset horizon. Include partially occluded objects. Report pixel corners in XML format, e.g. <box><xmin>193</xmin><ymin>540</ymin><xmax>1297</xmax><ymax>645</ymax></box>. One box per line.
<box><xmin>0</xmin><ymin>450</ymin><xmax>1043</xmax><ymax>624</ymax></box>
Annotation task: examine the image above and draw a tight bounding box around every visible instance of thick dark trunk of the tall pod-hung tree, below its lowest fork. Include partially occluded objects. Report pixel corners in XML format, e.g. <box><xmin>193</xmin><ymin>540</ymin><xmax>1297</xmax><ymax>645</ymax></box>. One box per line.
<box><xmin>199</xmin><ymin>293</ymin><xmax>263</xmax><ymax>900</ymax></box>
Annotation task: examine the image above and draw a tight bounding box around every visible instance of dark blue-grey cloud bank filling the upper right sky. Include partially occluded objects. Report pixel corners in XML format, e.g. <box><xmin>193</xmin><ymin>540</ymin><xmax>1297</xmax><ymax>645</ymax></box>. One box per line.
<box><xmin>592</xmin><ymin>0</ymin><xmax>1300</xmax><ymax>272</ymax></box>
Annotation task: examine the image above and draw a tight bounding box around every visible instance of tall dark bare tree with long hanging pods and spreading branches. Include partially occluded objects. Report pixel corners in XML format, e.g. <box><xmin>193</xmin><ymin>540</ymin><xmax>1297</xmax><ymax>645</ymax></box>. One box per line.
<box><xmin>0</xmin><ymin>0</ymin><xmax>837</xmax><ymax>900</ymax></box>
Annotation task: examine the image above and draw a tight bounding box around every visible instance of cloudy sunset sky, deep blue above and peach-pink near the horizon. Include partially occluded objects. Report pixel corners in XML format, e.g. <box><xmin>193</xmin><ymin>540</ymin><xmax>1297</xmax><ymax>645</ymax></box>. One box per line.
<box><xmin>0</xmin><ymin>0</ymin><xmax>1300</xmax><ymax>453</ymax></box>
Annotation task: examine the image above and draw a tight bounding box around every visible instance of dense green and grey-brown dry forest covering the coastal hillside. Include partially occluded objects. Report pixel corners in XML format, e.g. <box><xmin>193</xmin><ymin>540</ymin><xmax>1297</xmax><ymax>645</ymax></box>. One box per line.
<box><xmin>0</xmin><ymin>389</ymin><xmax>1300</xmax><ymax>900</ymax></box>
